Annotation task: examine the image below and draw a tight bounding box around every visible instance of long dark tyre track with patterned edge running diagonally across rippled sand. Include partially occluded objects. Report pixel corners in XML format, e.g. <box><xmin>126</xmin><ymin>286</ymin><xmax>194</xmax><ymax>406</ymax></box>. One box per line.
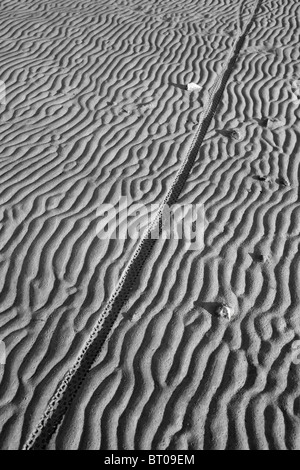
<box><xmin>23</xmin><ymin>0</ymin><xmax>263</xmax><ymax>450</ymax></box>
